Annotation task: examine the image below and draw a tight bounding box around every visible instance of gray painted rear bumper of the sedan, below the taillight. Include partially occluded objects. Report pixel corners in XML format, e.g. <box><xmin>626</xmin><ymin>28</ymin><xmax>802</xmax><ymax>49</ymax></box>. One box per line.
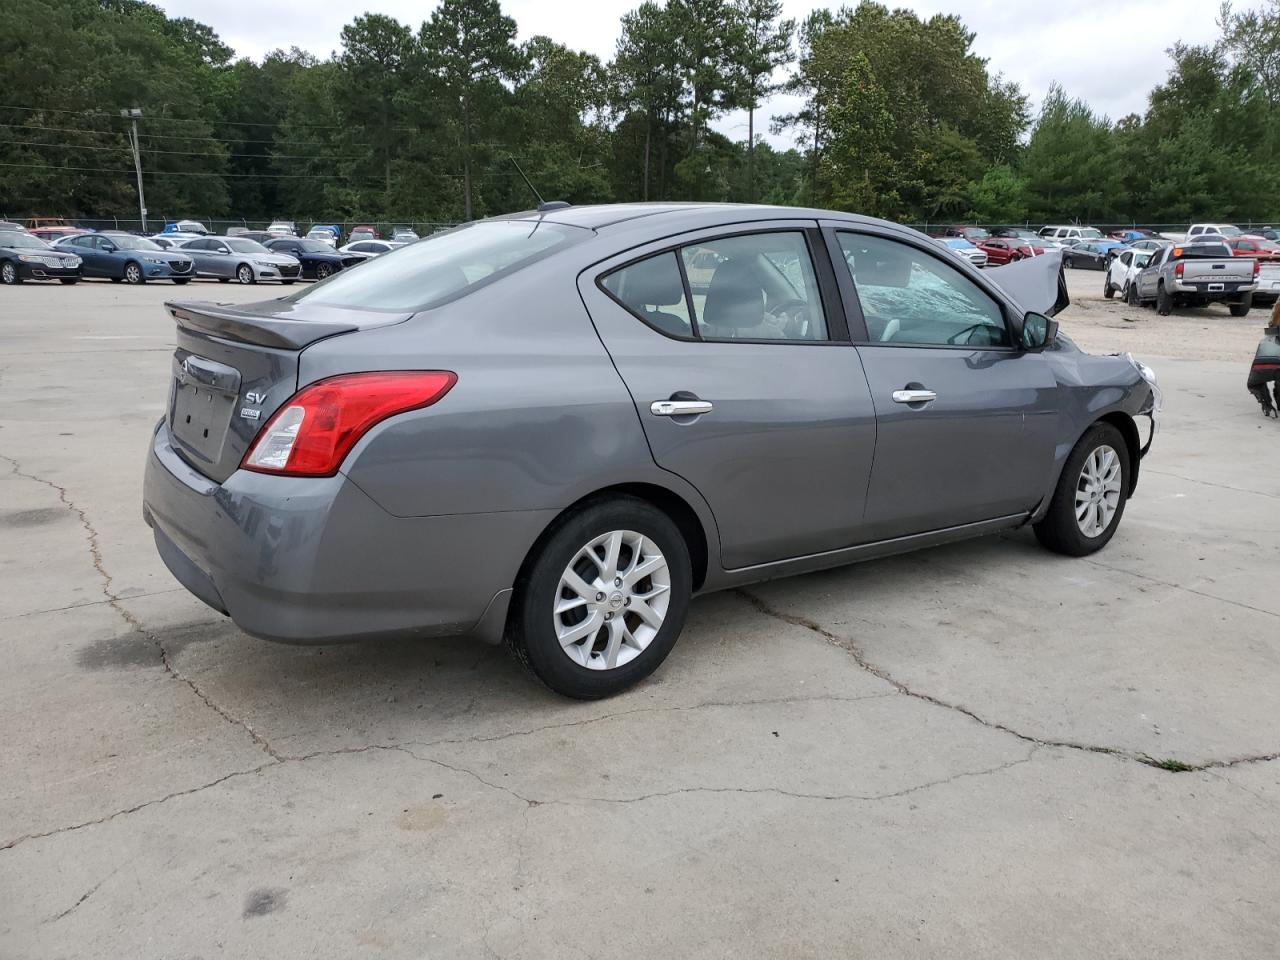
<box><xmin>143</xmin><ymin>422</ymin><xmax>554</xmax><ymax>644</ymax></box>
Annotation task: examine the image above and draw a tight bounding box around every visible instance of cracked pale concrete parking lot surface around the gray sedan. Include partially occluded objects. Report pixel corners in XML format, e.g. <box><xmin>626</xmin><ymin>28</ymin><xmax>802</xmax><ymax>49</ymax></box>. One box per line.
<box><xmin>0</xmin><ymin>271</ymin><xmax>1280</xmax><ymax>960</ymax></box>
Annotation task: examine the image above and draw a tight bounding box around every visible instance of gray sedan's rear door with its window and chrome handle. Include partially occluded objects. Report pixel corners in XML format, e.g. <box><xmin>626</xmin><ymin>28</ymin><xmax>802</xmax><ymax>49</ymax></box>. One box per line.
<box><xmin>579</xmin><ymin>221</ymin><xmax>876</xmax><ymax>570</ymax></box>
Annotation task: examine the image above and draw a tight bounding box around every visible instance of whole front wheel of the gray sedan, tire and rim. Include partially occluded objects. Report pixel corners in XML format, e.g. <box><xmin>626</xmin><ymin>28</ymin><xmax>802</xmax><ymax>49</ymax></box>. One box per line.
<box><xmin>1033</xmin><ymin>422</ymin><xmax>1130</xmax><ymax>557</ymax></box>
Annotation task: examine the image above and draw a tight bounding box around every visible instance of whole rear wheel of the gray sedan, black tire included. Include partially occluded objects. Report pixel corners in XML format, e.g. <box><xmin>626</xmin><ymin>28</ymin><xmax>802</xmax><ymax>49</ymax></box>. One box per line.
<box><xmin>507</xmin><ymin>497</ymin><xmax>692</xmax><ymax>700</ymax></box>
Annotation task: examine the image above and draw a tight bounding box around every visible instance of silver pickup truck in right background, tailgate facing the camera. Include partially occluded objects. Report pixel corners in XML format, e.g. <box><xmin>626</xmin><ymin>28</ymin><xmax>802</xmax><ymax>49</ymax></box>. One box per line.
<box><xmin>1133</xmin><ymin>243</ymin><xmax>1261</xmax><ymax>316</ymax></box>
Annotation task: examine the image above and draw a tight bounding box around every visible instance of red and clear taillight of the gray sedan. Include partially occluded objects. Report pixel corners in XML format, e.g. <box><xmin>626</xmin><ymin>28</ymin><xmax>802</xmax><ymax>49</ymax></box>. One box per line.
<box><xmin>241</xmin><ymin>370</ymin><xmax>458</xmax><ymax>476</ymax></box>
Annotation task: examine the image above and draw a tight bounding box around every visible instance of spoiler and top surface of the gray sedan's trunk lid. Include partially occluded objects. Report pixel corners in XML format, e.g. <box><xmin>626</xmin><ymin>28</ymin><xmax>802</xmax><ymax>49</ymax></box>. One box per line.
<box><xmin>164</xmin><ymin>300</ymin><xmax>411</xmax><ymax>349</ymax></box>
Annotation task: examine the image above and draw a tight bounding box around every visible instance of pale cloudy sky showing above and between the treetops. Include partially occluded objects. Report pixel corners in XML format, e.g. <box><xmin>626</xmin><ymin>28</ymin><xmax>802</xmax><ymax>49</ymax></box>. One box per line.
<box><xmin>154</xmin><ymin>0</ymin><xmax>1263</xmax><ymax>146</ymax></box>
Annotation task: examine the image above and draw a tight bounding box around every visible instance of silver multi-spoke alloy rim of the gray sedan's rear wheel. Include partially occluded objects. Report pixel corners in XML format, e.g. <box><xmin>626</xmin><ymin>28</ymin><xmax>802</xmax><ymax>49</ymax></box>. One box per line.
<box><xmin>552</xmin><ymin>530</ymin><xmax>671</xmax><ymax>669</ymax></box>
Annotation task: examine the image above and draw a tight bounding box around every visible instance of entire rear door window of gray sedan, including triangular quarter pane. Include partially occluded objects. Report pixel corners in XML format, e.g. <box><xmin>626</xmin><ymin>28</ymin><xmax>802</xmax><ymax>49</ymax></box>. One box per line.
<box><xmin>602</xmin><ymin>230</ymin><xmax>828</xmax><ymax>342</ymax></box>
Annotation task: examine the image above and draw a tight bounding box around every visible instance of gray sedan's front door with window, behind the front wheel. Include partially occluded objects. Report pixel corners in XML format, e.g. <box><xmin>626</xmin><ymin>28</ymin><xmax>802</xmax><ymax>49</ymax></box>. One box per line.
<box><xmin>835</xmin><ymin>230</ymin><xmax>1057</xmax><ymax>540</ymax></box>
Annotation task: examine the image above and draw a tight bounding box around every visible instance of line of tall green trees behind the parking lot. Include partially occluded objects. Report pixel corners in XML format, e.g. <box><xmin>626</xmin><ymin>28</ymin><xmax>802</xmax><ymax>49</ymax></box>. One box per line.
<box><xmin>0</xmin><ymin>0</ymin><xmax>1280</xmax><ymax>223</ymax></box>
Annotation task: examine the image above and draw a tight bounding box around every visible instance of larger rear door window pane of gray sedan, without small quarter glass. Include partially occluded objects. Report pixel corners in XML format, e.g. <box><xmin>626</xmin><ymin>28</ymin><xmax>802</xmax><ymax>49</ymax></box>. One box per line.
<box><xmin>680</xmin><ymin>232</ymin><xmax>827</xmax><ymax>340</ymax></box>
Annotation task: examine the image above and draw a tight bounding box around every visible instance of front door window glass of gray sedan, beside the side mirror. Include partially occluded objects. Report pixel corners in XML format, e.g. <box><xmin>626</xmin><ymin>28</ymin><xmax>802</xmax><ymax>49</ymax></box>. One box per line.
<box><xmin>840</xmin><ymin>233</ymin><xmax>1010</xmax><ymax>347</ymax></box>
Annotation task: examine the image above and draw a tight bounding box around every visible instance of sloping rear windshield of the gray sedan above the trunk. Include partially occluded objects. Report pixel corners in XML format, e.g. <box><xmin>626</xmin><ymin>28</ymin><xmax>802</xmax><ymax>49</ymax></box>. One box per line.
<box><xmin>285</xmin><ymin>220</ymin><xmax>591</xmax><ymax>311</ymax></box>
